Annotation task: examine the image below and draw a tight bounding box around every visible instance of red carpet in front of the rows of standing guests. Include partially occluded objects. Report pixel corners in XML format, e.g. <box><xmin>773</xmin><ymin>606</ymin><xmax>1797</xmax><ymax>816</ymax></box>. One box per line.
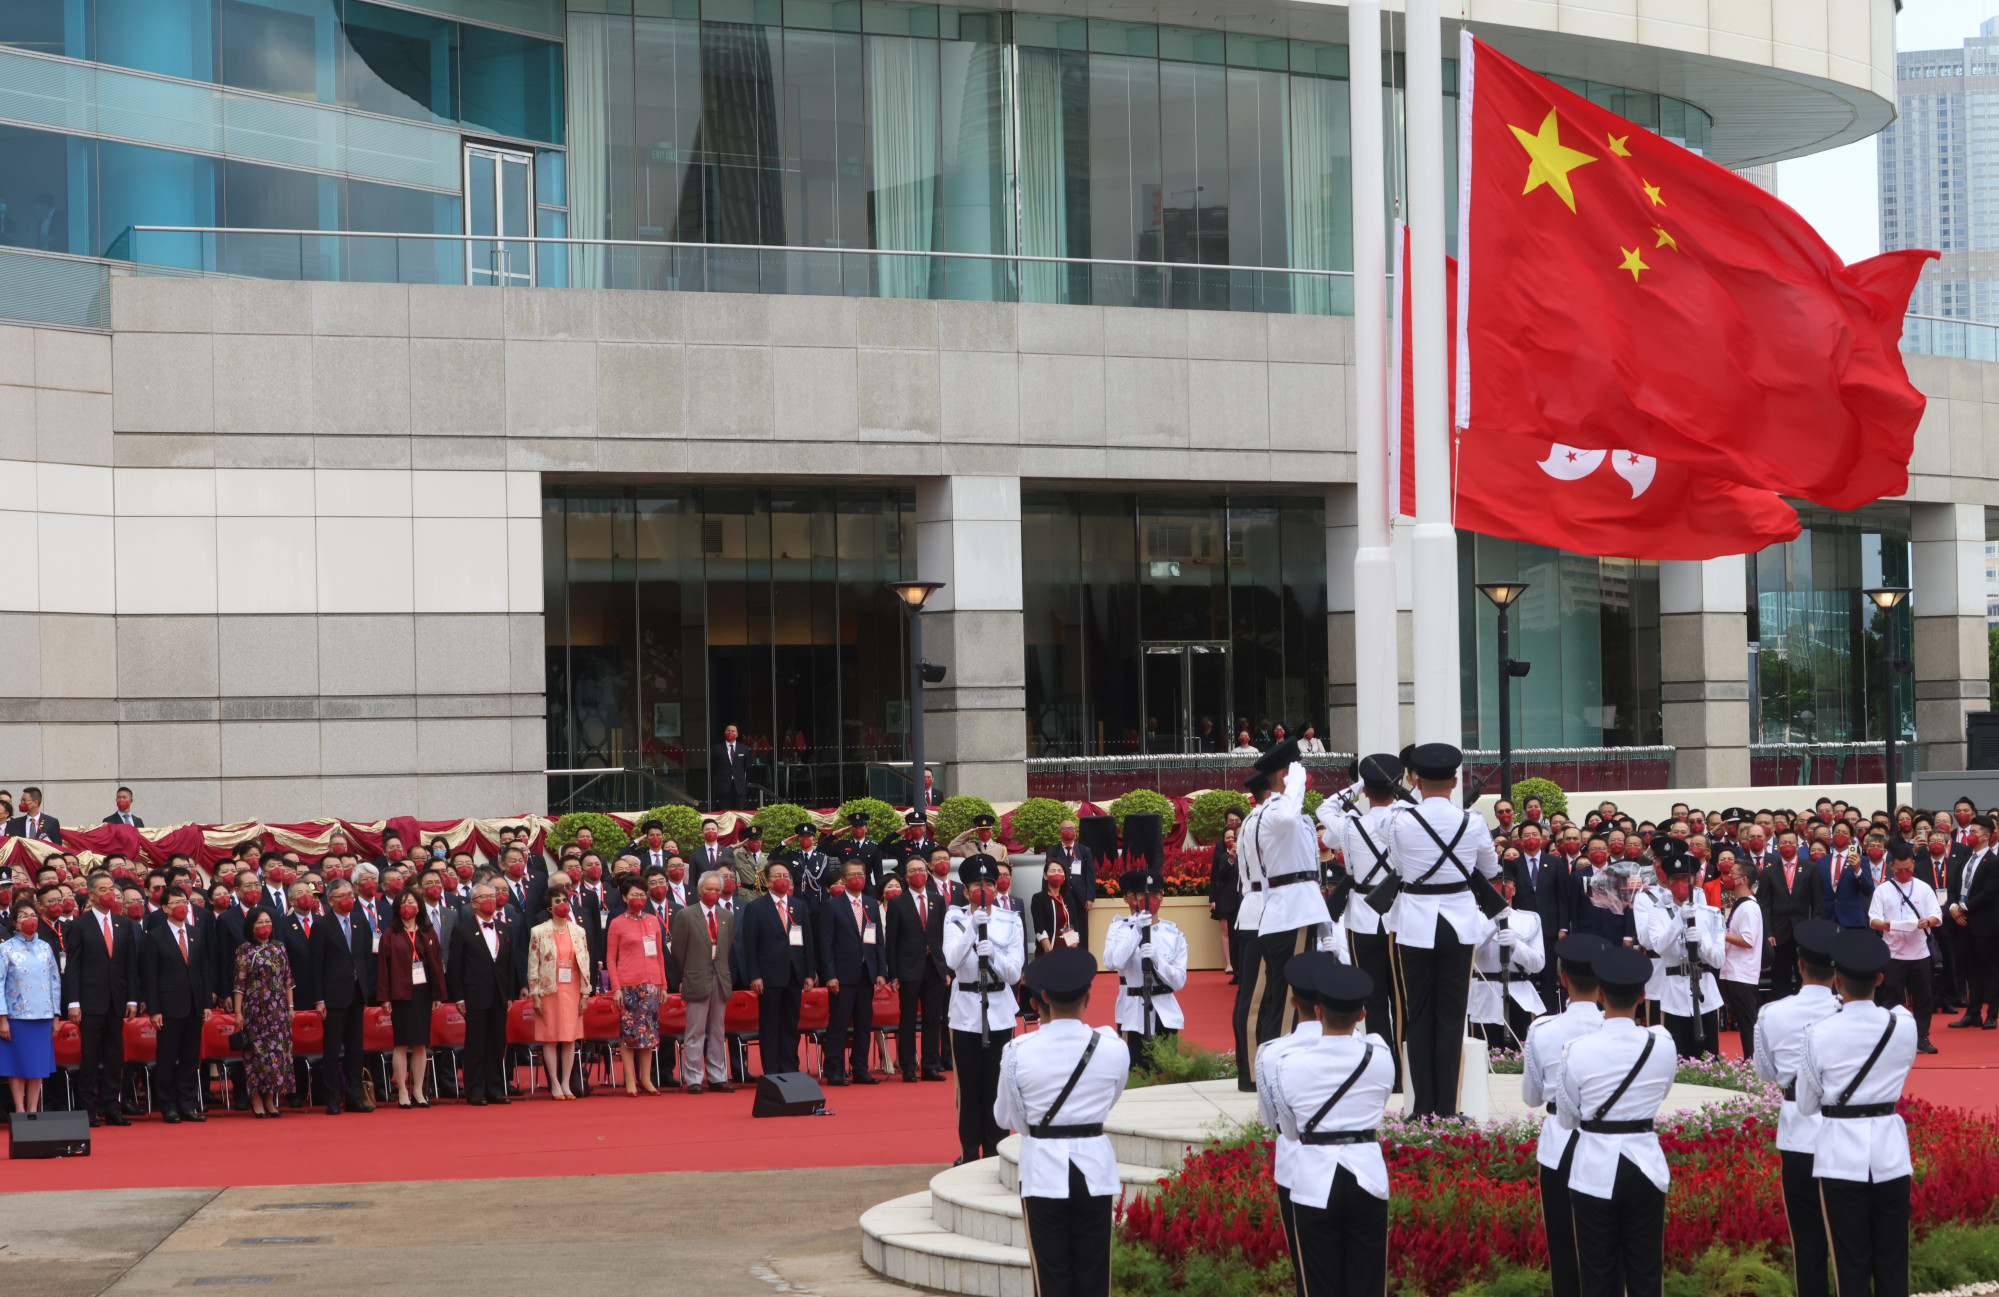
<box><xmin>0</xmin><ymin>973</ymin><xmax>1999</xmax><ymax>1193</ymax></box>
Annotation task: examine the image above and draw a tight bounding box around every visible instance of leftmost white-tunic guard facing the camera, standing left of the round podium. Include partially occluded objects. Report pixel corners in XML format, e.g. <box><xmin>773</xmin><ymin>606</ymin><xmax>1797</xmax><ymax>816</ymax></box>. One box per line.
<box><xmin>944</xmin><ymin>855</ymin><xmax>1027</xmax><ymax>1165</ymax></box>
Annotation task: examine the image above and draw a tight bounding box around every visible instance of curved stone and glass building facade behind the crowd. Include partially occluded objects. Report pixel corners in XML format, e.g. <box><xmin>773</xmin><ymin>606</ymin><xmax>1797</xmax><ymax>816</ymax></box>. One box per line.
<box><xmin>0</xmin><ymin>0</ymin><xmax>1975</xmax><ymax>821</ymax></box>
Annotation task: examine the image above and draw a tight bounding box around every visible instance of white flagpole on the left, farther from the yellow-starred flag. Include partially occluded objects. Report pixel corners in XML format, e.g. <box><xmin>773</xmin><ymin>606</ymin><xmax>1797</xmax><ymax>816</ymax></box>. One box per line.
<box><xmin>1347</xmin><ymin>0</ymin><xmax>1401</xmax><ymax>755</ymax></box>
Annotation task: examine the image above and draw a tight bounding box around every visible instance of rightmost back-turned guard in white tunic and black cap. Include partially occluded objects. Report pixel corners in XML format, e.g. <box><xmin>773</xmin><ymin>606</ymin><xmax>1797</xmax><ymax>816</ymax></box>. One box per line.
<box><xmin>1797</xmin><ymin>927</ymin><xmax>1917</xmax><ymax>1297</ymax></box>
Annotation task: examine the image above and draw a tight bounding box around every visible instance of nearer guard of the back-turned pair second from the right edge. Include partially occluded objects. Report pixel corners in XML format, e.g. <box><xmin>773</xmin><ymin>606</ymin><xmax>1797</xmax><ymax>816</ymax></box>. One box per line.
<box><xmin>1555</xmin><ymin>945</ymin><xmax>1679</xmax><ymax>1297</ymax></box>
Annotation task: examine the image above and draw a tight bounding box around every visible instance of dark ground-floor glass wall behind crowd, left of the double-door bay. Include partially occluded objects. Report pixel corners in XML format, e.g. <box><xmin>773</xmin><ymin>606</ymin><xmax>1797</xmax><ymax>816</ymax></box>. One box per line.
<box><xmin>542</xmin><ymin>486</ymin><xmax>916</xmax><ymax>805</ymax></box>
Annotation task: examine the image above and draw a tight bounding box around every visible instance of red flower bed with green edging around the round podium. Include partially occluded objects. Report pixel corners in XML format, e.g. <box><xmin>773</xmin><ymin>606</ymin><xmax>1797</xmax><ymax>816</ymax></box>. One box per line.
<box><xmin>1117</xmin><ymin>1091</ymin><xmax>1999</xmax><ymax>1297</ymax></box>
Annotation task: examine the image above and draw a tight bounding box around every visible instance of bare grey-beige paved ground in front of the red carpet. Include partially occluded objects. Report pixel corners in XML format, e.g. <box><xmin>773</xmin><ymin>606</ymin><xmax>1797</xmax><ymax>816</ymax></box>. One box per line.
<box><xmin>0</xmin><ymin>1165</ymin><xmax>938</xmax><ymax>1297</ymax></box>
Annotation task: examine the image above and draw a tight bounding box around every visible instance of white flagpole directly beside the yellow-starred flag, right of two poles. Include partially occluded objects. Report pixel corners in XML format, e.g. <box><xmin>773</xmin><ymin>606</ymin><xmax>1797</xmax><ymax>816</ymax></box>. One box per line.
<box><xmin>1407</xmin><ymin>0</ymin><xmax>1463</xmax><ymax>759</ymax></box>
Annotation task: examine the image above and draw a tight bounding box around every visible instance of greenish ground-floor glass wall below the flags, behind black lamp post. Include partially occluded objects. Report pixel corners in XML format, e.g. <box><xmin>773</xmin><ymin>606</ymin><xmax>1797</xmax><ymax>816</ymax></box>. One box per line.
<box><xmin>1457</xmin><ymin>532</ymin><xmax>1663</xmax><ymax>747</ymax></box>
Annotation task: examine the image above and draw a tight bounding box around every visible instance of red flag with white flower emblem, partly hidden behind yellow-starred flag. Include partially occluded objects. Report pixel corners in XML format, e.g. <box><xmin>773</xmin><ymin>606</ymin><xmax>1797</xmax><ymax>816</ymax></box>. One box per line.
<box><xmin>1389</xmin><ymin>226</ymin><xmax>1799</xmax><ymax>560</ymax></box>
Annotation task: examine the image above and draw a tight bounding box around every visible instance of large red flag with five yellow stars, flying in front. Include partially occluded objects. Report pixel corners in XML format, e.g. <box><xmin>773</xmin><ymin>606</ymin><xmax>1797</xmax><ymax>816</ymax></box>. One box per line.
<box><xmin>1455</xmin><ymin>32</ymin><xmax>1937</xmax><ymax>510</ymax></box>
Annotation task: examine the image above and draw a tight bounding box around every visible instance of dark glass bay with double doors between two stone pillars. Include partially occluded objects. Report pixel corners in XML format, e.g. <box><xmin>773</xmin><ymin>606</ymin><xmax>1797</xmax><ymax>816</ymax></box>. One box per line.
<box><xmin>1021</xmin><ymin>490</ymin><xmax>1327</xmax><ymax>755</ymax></box>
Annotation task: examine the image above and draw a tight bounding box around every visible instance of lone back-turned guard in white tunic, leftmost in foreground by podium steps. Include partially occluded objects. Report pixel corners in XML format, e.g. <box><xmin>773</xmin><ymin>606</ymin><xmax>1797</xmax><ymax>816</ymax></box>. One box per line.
<box><xmin>992</xmin><ymin>945</ymin><xmax>1129</xmax><ymax>1297</ymax></box>
